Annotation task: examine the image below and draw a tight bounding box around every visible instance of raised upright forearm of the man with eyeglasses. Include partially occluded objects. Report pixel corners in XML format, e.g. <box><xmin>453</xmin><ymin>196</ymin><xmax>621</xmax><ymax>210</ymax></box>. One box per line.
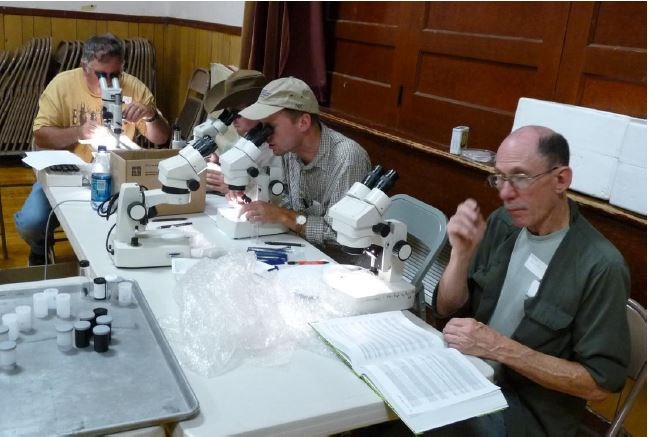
<box><xmin>436</xmin><ymin>251</ymin><xmax>470</xmax><ymax>316</ymax></box>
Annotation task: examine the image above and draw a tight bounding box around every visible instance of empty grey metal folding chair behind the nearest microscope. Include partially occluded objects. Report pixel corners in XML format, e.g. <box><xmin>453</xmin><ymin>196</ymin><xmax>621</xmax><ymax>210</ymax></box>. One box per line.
<box><xmin>384</xmin><ymin>194</ymin><xmax>448</xmax><ymax>319</ymax></box>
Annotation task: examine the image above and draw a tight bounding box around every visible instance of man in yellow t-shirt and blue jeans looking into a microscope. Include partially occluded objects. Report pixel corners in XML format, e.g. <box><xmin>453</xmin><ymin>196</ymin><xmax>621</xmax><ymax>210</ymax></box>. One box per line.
<box><xmin>14</xmin><ymin>34</ymin><xmax>171</xmax><ymax>265</ymax></box>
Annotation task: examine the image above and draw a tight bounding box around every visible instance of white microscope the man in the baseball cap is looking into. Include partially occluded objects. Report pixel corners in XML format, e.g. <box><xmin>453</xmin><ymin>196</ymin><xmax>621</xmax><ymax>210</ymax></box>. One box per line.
<box><xmin>214</xmin><ymin>123</ymin><xmax>288</xmax><ymax>239</ymax></box>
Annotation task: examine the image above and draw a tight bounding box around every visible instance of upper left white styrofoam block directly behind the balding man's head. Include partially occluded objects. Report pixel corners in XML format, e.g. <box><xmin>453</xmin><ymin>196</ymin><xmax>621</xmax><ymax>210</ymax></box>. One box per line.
<box><xmin>512</xmin><ymin>97</ymin><xmax>631</xmax><ymax>157</ymax></box>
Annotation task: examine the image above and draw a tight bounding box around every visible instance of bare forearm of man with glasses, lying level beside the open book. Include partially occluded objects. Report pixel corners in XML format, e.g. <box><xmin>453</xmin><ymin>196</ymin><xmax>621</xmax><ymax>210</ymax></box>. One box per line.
<box><xmin>494</xmin><ymin>336</ymin><xmax>610</xmax><ymax>401</ymax></box>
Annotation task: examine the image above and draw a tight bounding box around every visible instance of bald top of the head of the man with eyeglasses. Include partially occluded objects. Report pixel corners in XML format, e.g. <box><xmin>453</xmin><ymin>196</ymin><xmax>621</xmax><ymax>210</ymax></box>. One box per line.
<box><xmin>500</xmin><ymin>126</ymin><xmax>570</xmax><ymax>166</ymax></box>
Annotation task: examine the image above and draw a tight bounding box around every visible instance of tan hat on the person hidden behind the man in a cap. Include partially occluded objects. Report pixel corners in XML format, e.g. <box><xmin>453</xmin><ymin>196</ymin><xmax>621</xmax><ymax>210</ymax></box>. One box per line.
<box><xmin>203</xmin><ymin>70</ymin><xmax>268</xmax><ymax>114</ymax></box>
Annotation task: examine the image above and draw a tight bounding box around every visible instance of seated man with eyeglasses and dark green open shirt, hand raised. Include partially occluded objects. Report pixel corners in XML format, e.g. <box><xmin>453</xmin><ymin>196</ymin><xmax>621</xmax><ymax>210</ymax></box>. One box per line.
<box><xmin>434</xmin><ymin>126</ymin><xmax>630</xmax><ymax>436</ymax></box>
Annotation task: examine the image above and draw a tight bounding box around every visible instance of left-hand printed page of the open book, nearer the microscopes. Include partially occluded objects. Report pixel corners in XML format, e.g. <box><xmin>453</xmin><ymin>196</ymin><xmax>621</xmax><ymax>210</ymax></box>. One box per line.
<box><xmin>312</xmin><ymin>311</ymin><xmax>444</xmax><ymax>368</ymax></box>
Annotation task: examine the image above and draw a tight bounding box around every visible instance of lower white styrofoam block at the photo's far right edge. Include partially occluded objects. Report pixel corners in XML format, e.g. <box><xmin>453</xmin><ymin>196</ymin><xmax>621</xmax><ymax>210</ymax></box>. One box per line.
<box><xmin>610</xmin><ymin>163</ymin><xmax>647</xmax><ymax>215</ymax></box>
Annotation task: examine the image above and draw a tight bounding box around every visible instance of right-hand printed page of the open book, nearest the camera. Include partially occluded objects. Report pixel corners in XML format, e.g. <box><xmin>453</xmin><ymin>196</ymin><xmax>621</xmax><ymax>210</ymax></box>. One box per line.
<box><xmin>358</xmin><ymin>349</ymin><xmax>499</xmax><ymax>415</ymax></box>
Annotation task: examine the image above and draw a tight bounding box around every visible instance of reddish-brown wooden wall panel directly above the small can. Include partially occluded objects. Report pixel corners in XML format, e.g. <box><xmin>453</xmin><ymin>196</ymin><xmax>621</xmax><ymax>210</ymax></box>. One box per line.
<box><xmin>397</xmin><ymin>2</ymin><xmax>569</xmax><ymax>150</ymax></box>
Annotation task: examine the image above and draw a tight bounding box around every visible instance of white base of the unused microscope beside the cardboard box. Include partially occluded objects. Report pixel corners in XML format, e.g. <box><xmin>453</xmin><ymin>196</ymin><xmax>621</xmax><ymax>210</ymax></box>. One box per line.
<box><xmin>113</xmin><ymin>238</ymin><xmax>191</xmax><ymax>268</ymax></box>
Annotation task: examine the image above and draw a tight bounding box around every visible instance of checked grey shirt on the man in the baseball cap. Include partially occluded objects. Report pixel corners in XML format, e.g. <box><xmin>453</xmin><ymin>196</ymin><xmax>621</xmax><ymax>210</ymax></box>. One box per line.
<box><xmin>280</xmin><ymin>124</ymin><xmax>370</xmax><ymax>244</ymax></box>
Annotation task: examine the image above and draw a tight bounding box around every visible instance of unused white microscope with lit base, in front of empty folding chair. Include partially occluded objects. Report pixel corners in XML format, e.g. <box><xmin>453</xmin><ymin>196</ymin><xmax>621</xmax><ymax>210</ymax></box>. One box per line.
<box><xmin>323</xmin><ymin>166</ymin><xmax>415</xmax><ymax>313</ymax></box>
